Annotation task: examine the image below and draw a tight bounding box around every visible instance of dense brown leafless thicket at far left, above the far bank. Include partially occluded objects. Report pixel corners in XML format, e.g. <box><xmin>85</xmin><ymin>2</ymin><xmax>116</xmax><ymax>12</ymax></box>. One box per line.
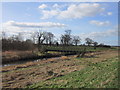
<box><xmin>2</xmin><ymin>34</ymin><xmax>34</xmax><ymax>51</ymax></box>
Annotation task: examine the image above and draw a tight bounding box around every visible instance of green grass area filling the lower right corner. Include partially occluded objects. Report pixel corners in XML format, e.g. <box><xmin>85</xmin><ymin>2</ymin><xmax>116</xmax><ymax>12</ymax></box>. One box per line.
<box><xmin>27</xmin><ymin>57</ymin><xmax>118</xmax><ymax>89</ymax></box>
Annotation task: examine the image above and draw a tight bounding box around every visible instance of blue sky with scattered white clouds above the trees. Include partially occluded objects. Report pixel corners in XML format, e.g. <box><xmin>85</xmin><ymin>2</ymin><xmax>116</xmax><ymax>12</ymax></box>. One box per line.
<box><xmin>2</xmin><ymin>2</ymin><xmax>118</xmax><ymax>45</ymax></box>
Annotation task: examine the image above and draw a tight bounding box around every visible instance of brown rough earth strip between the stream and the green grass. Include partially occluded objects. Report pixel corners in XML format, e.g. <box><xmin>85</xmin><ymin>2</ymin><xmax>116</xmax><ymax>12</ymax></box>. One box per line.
<box><xmin>2</xmin><ymin>50</ymin><xmax>118</xmax><ymax>88</ymax></box>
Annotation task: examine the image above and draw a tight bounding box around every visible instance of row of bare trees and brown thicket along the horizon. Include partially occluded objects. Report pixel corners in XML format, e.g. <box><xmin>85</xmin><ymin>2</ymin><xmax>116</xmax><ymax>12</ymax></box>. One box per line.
<box><xmin>0</xmin><ymin>30</ymin><xmax>110</xmax><ymax>51</ymax></box>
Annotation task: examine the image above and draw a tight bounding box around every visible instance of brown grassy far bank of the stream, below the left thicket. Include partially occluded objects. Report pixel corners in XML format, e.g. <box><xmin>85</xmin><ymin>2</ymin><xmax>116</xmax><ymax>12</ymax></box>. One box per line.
<box><xmin>2</xmin><ymin>51</ymin><xmax>63</xmax><ymax>64</ymax></box>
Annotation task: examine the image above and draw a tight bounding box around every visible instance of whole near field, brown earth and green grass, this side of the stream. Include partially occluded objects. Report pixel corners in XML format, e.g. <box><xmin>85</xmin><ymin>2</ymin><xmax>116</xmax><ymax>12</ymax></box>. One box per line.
<box><xmin>2</xmin><ymin>49</ymin><xmax>118</xmax><ymax>90</ymax></box>
